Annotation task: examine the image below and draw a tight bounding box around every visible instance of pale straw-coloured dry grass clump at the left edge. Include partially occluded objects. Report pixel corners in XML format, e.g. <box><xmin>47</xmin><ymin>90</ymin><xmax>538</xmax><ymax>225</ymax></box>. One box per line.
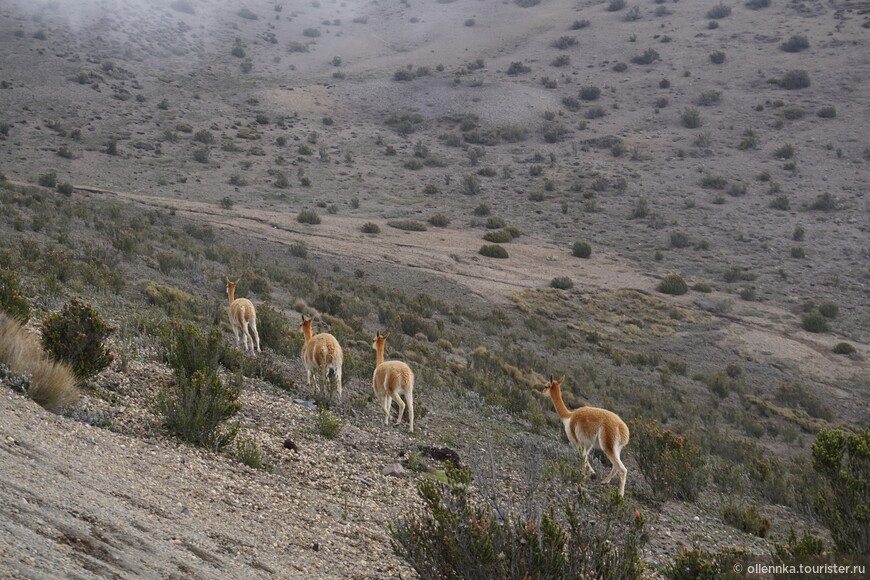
<box><xmin>0</xmin><ymin>312</ymin><xmax>79</xmax><ymax>411</ymax></box>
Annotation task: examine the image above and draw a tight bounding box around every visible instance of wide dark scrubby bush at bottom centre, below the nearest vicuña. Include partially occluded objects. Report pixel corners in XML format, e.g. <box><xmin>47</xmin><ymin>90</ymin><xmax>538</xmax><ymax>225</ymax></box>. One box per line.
<box><xmin>390</xmin><ymin>468</ymin><xmax>646</xmax><ymax>580</ymax></box>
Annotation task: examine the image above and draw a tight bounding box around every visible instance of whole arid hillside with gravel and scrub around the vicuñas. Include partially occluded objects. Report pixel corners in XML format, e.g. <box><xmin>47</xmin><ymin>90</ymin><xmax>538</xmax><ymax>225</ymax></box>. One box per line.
<box><xmin>0</xmin><ymin>0</ymin><xmax>870</xmax><ymax>578</ymax></box>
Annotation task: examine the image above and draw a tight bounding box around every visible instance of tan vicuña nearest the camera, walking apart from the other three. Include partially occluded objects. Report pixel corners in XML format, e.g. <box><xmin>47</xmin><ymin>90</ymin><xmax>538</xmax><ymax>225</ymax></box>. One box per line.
<box><xmin>545</xmin><ymin>376</ymin><xmax>629</xmax><ymax>495</ymax></box>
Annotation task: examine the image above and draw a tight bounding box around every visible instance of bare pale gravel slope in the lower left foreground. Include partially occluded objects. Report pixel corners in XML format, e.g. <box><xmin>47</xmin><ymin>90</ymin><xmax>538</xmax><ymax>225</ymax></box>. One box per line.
<box><xmin>0</xmin><ymin>372</ymin><xmax>416</xmax><ymax>579</ymax></box>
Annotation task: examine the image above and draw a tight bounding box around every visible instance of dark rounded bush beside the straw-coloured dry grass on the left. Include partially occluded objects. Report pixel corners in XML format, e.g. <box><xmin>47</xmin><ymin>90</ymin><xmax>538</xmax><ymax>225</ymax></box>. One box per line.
<box><xmin>42</xmin><ymin>298</ymin><xmax>115</xmax><ymax>380</ymax></box>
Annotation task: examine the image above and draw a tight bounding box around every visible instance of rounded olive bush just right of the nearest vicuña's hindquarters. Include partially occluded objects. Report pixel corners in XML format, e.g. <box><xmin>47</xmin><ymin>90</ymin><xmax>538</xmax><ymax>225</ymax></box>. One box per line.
<box><xmin>631</xmin><ymin>419</ymin><xmax>707</xmax><ymax>501</ymax></box>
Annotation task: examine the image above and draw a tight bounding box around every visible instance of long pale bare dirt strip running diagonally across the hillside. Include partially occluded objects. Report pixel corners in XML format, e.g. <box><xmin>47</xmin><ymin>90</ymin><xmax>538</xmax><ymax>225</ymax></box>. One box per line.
<box><xmin>59</xmin><ymin>186</ymin><xmax>870</xmax><ymax>394</ymax></box>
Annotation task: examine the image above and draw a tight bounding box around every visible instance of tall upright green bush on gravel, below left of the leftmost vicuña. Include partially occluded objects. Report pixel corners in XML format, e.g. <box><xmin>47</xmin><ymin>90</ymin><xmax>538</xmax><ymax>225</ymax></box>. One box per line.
<box><xmin>157</xmin><ymin>323</ymin><xmax>242</xmax><ymax>451</ymax></box>
